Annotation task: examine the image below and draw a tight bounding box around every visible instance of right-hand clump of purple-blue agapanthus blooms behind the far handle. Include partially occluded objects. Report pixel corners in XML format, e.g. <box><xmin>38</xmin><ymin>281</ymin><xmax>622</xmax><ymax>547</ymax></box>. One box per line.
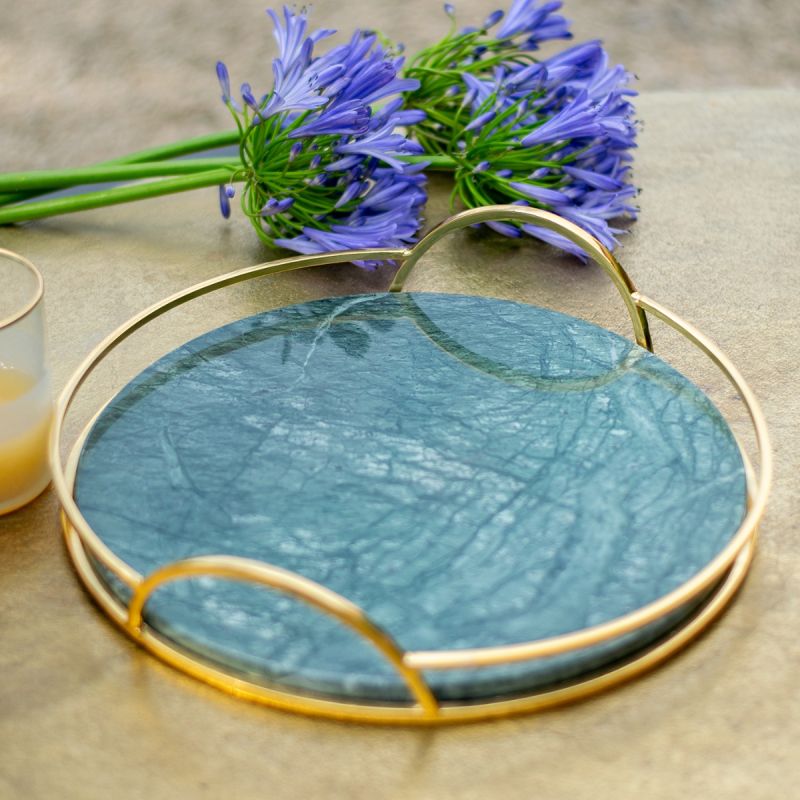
<box><xmin>407</xmin><ymin>0</ymin><xmax>637</xmax><ymax>258</ymax></box>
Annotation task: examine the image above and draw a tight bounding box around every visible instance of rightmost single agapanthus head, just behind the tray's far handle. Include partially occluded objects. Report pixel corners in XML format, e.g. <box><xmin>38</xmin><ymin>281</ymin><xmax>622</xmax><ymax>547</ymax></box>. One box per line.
<box><xmin>446</xmin><ymin>24</ymin><xmax>637</xmax><ymax>257</ymax></box>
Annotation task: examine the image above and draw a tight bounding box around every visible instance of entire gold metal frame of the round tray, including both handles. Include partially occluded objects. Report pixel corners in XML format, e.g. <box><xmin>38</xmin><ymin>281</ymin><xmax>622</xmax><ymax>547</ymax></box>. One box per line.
<box><xmin>49</xmin><ymin>206</ymin><xmax>772</xmax><ymax>725</ymax></box>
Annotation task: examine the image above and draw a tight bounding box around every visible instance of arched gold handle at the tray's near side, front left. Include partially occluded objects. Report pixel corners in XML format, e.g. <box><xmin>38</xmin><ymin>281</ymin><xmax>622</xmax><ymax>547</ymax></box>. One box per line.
<box><xmin>127</xmin><ymin>556</ymin><xmax>439</xmax><ymax>716</ymax></box>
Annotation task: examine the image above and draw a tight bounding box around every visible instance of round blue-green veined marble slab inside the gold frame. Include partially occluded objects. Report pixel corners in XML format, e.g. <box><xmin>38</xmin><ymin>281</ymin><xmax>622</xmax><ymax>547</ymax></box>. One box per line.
<box><xmin>76</xmin><ymin>293</ymin><xmax>746</xmax><ymax>700</ymax></box>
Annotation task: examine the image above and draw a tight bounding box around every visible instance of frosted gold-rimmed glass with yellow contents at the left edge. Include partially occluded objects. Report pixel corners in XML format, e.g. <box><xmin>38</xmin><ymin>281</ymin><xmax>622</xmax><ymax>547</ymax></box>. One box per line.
<box><xmin>0</xmin><ymin>248</ymin><xmax>52</xmax><ymax>514</ymax></box>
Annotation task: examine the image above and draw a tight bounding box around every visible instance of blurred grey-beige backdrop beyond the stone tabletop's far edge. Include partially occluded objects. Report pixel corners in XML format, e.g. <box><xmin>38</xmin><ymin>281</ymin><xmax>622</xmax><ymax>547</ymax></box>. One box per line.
<box><xmin>0</xmin><ymin>0</ymin><xmax>800</xmax><ymax>170</ymax></box>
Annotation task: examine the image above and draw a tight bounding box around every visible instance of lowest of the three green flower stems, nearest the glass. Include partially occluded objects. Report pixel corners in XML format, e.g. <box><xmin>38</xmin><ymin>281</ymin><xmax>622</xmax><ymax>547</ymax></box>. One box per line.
<box><xmin>0</xmin><ymin>169</ymin><xmax>231</xmax><ymax>225</ymax></box>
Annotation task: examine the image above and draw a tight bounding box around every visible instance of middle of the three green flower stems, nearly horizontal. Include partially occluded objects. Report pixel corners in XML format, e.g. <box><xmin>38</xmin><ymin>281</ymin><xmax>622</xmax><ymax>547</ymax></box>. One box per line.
<box><xmin>0</xmin><ymin>158</ymin><xmax>240</xmax><ymax>192</ymax></box>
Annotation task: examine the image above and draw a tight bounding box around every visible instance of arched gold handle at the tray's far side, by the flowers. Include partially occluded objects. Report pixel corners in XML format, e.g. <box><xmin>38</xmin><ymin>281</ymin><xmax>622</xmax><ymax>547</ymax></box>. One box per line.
<box><xmin>389</xmin><ymin>205</ymin><xmax>653</xmax><ymax>352</ymax></box>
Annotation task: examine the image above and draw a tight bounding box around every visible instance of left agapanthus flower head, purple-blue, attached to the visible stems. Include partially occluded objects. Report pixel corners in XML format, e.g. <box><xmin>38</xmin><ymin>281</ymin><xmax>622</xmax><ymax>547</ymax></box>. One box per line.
<box><xmin>217</xmin><ymin>8</ymin><xmax>426</xmax><ymax>268</ymax></box>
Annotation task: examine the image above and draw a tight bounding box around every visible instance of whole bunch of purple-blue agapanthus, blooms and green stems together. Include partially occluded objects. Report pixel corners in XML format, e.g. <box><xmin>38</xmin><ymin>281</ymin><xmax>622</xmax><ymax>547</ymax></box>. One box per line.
<box><xmin>0</xmin><ymin>0</ymin><xmax>637</xmax><ymax>267</ymax></box>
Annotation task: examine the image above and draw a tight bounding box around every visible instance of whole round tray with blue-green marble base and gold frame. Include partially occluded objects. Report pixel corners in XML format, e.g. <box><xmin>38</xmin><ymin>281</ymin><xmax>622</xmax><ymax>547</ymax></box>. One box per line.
<box><xmin>51</xmin><ymin>206</ymin><xmax>771</xmax><ymax>724</ymax></box>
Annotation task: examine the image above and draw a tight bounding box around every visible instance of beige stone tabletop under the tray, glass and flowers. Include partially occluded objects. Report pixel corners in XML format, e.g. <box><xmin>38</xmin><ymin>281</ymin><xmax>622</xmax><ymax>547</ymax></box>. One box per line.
<box><xmin>0</xmin><ymin>90</ymin><xmax>800</xmax><ymax>800</ymax></box>
